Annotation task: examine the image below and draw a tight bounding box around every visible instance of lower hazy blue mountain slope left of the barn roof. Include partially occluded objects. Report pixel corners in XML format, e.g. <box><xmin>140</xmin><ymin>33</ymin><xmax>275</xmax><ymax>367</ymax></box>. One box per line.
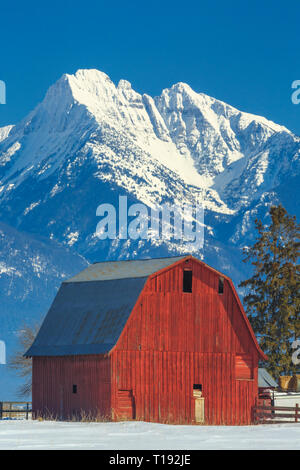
<box><xmin>0</xmin><ymin>223</ymin><xmax>88</xmax><ymax>401</ymax></box>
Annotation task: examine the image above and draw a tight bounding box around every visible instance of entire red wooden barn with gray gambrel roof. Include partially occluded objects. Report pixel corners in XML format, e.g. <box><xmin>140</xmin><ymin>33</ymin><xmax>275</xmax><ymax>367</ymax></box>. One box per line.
<box><xmin>26</xmin><ymin>256</ymin><xmax>266</xmax><ymax>425</ymax></box>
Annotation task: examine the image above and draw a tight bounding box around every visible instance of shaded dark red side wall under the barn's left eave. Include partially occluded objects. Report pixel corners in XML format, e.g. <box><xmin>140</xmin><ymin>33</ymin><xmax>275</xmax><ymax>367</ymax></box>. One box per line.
<box><xmin>32</xmin><ymin>355</ymin><xmax>111</xmax><ymax>419</ymax></box>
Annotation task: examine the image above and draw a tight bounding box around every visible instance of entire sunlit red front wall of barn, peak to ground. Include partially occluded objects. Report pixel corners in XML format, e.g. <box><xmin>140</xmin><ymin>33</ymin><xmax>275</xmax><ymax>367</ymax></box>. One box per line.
<box><xmin>111</xmin><ymin>261</ymin><xmax>258</xmax><ymax>424</ymax></box>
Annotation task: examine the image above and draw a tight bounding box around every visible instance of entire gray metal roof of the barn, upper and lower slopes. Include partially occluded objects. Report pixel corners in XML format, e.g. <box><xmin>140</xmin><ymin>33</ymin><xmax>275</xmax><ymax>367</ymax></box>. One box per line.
<box><xmin>25</xmin><ymin>256</ymin><xmax>189</xmax><ymax>356</ymax></box>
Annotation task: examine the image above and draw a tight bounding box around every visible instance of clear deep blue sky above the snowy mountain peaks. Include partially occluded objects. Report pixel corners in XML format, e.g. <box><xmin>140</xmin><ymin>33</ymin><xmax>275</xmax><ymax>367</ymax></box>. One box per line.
<box><xmin>0</xmin><ymin>0</ymin><xmax>300</xmax><ymax>134</ymax></box>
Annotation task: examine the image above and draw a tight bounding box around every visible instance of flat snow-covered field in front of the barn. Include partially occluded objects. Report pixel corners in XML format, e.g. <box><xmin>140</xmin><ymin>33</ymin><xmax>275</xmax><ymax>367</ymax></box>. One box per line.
<box><xmin>0</xmin><ymin>420</ymin><xmax>300</xmax><ymax>450</ymax></box>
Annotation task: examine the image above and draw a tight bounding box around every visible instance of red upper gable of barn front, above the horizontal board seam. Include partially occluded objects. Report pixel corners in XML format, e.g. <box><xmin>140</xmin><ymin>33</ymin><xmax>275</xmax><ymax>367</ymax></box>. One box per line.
<box><xmin>114</xmin><ymin>256</ymin><xmax>267</xmax><ymax>360</ymax></box>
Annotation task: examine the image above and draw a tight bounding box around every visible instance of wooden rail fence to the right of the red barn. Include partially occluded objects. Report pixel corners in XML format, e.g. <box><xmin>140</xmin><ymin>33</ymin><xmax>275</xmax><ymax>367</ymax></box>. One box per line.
<box><xmin>253</xmin><ymin>403</ymin><xmax>300</xmax><ymax>424</ymax></box>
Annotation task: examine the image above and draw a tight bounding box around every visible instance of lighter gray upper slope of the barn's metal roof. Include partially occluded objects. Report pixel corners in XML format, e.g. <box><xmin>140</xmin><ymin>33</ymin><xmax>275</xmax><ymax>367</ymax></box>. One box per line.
<box><xmin>65</xmin><ymin>256</ymin><xmax>185</xmax><ymax>282</ymax></box>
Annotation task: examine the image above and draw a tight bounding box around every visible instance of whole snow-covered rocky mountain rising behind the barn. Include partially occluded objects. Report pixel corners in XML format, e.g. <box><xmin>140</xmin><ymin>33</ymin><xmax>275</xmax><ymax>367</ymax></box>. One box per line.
<box><xmin>0</xmin><ymin>70</ymin><xmax>300</xmax><ymax>399</ymax></box>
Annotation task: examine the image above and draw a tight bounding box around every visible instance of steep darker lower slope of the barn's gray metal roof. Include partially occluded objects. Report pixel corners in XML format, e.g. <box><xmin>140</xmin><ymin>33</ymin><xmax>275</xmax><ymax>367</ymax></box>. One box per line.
<box><xmin>26</xmin><ymin>277</ymin><xmax>147</xmax><ymax>357</ymax></box>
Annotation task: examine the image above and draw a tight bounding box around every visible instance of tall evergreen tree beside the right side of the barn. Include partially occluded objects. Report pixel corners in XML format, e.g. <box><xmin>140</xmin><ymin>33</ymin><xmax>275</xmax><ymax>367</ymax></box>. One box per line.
<box><xmin>240</xmin><ymin>205</ymin><xmax>300</xmax><ymax>378</ymax></box>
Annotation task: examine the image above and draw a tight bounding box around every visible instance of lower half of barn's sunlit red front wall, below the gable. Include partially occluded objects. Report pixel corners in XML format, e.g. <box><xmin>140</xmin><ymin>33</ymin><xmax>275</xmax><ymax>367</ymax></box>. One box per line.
<box><xmin>112</xmin><ymin>351</ymin><xmax>257</xmax><ymax>425</ymax></box>
